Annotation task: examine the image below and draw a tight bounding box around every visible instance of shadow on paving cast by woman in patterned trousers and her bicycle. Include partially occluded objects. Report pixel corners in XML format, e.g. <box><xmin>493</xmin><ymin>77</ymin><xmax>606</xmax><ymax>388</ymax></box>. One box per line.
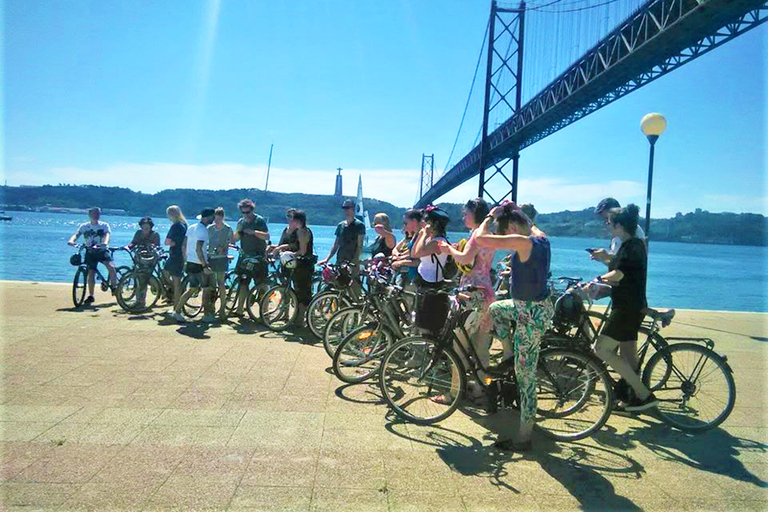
<box><xmin>385</xmin><ymin>411</ymin><xmax>645</xmax><ymax>511</ymax></box>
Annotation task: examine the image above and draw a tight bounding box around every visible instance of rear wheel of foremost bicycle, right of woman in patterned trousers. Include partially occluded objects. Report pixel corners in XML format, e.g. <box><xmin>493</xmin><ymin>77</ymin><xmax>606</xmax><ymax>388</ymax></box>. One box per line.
<box><xmin>536</xmin><ymin>348</ymin><xmax>613</xmax><ymax>441</ymax></box>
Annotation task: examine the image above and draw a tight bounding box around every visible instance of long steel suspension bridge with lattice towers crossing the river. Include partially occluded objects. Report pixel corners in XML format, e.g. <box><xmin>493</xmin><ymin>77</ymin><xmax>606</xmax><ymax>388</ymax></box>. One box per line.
<box><xmin>415</xmin><ymin>0</ymin><xmax>768</xmax><ymax>208</ymax></box>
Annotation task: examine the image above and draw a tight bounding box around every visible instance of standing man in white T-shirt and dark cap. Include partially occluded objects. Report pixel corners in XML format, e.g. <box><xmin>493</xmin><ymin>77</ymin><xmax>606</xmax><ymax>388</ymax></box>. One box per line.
<box><xmin>173</xmin><ymin>208</ymin><xmax>216</xmax><ymax>323</ymax></box>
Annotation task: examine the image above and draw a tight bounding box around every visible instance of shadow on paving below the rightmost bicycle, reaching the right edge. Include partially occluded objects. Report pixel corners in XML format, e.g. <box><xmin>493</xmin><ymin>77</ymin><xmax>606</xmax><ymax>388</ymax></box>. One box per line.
<box><xmin>594</xmin><ymin>416</ymin><xmax>768</xmax><ymax>488</ymax></box>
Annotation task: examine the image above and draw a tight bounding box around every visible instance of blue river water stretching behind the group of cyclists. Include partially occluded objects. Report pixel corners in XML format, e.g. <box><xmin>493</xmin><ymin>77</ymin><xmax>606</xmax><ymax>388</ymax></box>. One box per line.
<box><xmin>0</xmin><ymin>212</ymin><xmax>768</xmax><ymax>312</ymax></box>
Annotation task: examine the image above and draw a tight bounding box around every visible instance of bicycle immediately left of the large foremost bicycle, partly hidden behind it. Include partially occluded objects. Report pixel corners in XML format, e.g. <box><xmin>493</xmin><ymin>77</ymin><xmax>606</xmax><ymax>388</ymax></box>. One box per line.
<box><xmin>333</xmin><ymin>268</ymin><xmax>413</xmax><ymax>384</ymax></box>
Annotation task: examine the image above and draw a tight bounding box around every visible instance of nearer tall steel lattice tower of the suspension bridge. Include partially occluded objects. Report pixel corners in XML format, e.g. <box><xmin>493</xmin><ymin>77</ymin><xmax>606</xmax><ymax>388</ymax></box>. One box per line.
<box><xmin>477</xmin><ymin>0</ymin><xmax>525</xmax><ymax>204</ymax></box>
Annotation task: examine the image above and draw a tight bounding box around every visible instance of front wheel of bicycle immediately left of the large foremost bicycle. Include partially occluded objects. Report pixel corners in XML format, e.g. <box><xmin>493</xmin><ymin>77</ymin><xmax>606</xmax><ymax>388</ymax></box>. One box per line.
<box><xmin>333</xmin><ymin>322</ymin><xmax>395</xmax><ymax>384</ymax></box>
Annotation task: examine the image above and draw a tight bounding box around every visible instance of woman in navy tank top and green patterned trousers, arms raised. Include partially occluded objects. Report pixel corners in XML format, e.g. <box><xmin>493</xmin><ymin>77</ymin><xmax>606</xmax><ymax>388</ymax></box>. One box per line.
<box><xmin>476</xmin><ymin>202</ymin><xmax>554</xmax><ymax>451</ymax></box>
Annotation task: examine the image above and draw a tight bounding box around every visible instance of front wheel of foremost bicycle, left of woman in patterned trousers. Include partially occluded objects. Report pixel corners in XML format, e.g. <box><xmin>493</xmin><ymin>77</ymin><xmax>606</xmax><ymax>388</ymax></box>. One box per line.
<box><xmin>379</xmin><ymin>337</ymin><xmax>467</xmax><ymax>425</ymax></box>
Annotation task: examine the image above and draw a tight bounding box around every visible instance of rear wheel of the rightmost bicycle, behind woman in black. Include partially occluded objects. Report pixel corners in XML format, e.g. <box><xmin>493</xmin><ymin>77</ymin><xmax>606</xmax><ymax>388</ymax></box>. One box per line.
<box><xmin>643</xmin><ymin>343</ymin><xmax>736</xmax><ymax>432</ymax></box>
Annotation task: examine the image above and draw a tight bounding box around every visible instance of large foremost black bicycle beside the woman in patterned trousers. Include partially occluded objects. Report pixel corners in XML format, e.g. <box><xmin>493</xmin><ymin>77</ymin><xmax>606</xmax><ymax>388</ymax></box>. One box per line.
<box><xmin>379</xmin><ymin>286</ymin><xmax>613</xmax><ymax>441</ymax></box>
